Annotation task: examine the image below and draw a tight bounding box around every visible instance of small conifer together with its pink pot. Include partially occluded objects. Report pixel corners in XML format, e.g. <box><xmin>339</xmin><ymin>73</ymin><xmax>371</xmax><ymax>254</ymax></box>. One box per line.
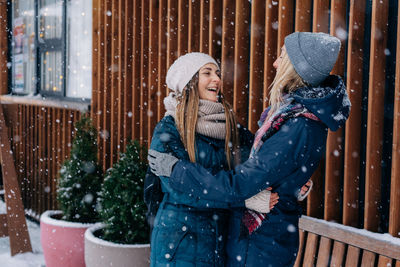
<box><xmin>40</xmin><ymin>115</ymin><xmax>102</xmax><ymax>267</ymax></box>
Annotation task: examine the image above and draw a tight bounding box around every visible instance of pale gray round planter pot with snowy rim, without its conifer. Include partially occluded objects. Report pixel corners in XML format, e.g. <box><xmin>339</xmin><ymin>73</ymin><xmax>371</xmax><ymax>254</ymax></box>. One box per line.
<box><xmin>85</xmin><ymin>224</ymin><xmax>150</xmax><ymax>267</ymax></box>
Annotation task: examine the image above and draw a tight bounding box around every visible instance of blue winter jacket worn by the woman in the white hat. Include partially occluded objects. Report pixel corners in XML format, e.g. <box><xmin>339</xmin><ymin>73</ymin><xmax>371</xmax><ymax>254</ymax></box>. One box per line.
<box><xmin>150</xmin><ymin>116</ymin><xmax>253</xmax><ymax>267</ymax></box>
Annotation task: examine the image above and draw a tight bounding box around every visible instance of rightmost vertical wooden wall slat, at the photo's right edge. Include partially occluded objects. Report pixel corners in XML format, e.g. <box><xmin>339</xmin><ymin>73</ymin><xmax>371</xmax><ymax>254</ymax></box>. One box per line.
<box><xmin>389</xmin><ymin>0</ymin><xmax>400</xmax><ymax>237</ymax></box>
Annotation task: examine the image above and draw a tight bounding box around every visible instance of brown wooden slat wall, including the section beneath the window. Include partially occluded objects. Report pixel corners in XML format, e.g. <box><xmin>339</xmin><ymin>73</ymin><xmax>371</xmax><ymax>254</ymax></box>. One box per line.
<box><xmin>0</xmin><ymin>0</ymin><xmax>400</xmax><ymax>242</ymax></box>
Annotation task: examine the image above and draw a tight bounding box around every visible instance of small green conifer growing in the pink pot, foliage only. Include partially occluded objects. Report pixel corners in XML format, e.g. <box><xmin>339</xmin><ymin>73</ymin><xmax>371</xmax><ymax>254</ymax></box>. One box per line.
<box><xmin>57</xmin><ymin>115</ymin><xmax>102</xmax><ymax>223</ymax></box>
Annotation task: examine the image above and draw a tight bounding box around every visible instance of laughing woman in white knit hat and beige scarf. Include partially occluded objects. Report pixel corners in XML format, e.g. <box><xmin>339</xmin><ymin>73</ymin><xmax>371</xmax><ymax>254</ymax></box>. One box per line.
<box><xmin>145</xmin><ymin>53</ymin><xmax>277</xmax><ymax>267</ymax></box>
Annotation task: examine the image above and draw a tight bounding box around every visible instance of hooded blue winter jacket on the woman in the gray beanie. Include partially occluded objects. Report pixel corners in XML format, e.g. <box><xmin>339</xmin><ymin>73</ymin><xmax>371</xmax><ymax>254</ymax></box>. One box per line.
<box><xmin>170</xmin><ymin>76</ymin><xmax>350</xmax><ymax>267</ymax></box>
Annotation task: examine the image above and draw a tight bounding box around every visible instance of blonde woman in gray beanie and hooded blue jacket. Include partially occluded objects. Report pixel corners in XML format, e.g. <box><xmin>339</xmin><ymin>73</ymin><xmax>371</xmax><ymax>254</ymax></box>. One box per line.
<box><xmin>149</xmin><ymin>32</ymin><xmax>350</xmax><ymax>267</ymax></box>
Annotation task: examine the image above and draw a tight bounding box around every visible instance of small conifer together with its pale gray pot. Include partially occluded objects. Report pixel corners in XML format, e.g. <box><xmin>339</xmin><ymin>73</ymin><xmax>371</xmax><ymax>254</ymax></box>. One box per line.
<box><xmin>85</xmin><ymin>141</ymin><xmax>150</xmax><ymax>267</ymax></box>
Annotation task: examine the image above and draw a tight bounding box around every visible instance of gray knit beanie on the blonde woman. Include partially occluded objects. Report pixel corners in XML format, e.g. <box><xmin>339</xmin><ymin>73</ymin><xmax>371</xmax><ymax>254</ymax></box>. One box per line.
<box><xmin>285</xmin><ymin>32</ymin><xmax>340</xmax><ymax>86</ymax></box>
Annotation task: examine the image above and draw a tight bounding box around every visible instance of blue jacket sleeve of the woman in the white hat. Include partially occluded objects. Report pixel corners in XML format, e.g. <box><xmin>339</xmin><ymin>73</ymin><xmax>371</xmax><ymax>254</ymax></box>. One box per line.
<box><xmin>150</xmin><ymin>118</ymin><xmax>238</xmax><ymax>209</ymax></box>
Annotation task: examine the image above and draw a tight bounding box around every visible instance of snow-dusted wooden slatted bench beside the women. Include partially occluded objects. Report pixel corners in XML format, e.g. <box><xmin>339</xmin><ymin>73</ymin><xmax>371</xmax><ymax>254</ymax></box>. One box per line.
<box><xmin>294</xmin><ymin>216</ymin><xmax>400</xmax><ymax>267</ymax></box>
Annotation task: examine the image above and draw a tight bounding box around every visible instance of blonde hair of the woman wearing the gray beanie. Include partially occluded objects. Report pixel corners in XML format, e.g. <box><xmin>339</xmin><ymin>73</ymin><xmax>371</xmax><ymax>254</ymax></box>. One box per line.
<box><xmin>267</xmin><ymin>50</ymin><xmax>307</xmax><ymax>119</ymax></box>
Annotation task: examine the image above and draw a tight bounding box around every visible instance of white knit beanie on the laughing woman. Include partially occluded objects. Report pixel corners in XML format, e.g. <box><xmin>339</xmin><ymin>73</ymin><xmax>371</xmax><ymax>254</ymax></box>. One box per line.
<box><xmin>166</xmin><ymin>52</ymin><xmax>219</xmax><ymax>94</ymax></box>
